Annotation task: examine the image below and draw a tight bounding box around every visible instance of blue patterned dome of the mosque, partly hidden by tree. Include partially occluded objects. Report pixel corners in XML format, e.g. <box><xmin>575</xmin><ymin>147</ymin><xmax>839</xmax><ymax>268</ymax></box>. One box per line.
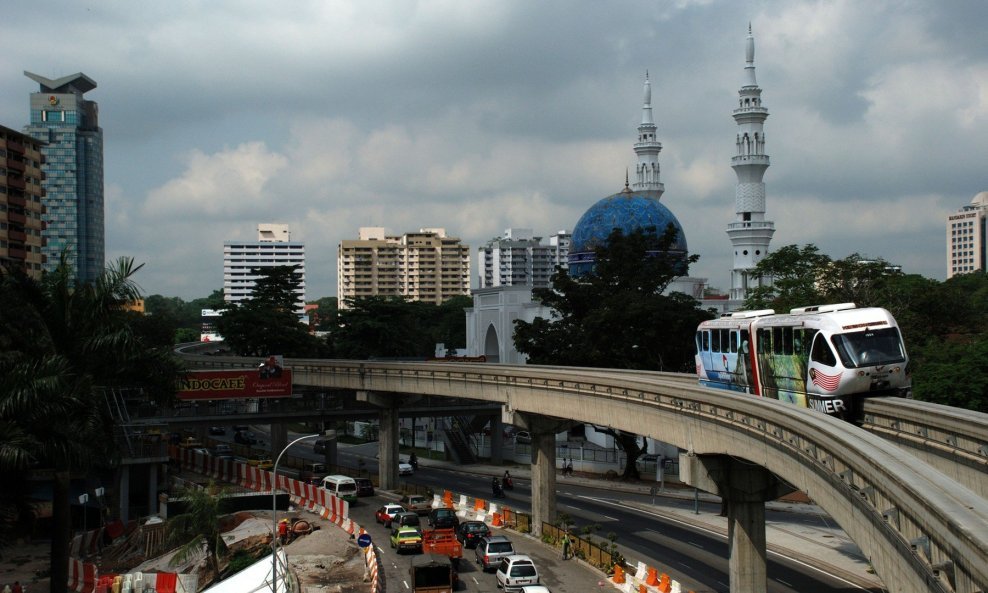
<box><xmin>568</xmin><ymin>186</ymin><xmax>688</xmax><ymax>277</ymax></box>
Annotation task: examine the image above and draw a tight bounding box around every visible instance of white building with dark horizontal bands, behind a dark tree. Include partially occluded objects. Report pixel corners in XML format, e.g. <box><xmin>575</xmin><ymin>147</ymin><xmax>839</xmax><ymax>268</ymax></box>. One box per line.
<box><xmin>223</xmin><ymin>223</ymin><xmax>305</xmax><ymax>316</ymax></box>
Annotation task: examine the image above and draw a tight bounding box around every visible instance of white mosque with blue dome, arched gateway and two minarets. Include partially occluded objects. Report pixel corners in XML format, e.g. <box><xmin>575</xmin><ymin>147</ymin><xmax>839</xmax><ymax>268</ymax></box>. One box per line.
<box><xmin>466</xmin><ymin>24</ymin><xmax>775</xmax><ymax>364</ymax></box>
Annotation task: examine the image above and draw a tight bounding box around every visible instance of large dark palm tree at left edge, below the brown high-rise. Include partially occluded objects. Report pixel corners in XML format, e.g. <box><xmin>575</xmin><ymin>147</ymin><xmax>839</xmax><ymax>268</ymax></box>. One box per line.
<box><xmin>0</xmin><ymin>254</ymin><xmax>176</xmax><ymax>593</ymax></box>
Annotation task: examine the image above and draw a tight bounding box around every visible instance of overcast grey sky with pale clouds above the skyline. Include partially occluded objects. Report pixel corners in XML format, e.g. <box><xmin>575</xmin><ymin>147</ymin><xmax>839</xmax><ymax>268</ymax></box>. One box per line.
<box><xmin>0</xmin><ymin>0</ymin><xmax>988</xmax><ymax>299</ymax></box>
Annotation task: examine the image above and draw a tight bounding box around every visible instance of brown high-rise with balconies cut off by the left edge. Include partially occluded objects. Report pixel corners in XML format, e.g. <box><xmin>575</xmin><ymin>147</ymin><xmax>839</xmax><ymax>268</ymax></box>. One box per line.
<box><xmin>0</xmin><ymin>126</ymin><xmax>45</xmax><ymax>278</ymax></box>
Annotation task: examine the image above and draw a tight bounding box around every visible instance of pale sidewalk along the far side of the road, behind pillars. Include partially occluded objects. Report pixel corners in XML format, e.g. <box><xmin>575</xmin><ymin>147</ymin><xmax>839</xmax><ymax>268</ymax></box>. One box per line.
<box><xmin>419</xmin><ymin>458</ymin><xmax>884</xmax><ymax>589</ymax></box>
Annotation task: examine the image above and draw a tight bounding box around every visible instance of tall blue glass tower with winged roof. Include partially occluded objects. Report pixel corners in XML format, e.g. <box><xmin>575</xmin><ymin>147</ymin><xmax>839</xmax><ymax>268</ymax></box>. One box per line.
<box><xmin>24</xmin><ymin>72</ymin><xmax>105</xmax><ymax>282</ymax></box>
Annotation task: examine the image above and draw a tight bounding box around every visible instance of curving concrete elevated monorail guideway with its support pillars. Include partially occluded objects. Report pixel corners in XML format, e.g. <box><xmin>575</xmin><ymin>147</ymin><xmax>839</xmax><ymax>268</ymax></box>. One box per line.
<box><xmin>184</xmin><ymin>356</ymin><xmax>988</xmax><ymax>593</ymax></box>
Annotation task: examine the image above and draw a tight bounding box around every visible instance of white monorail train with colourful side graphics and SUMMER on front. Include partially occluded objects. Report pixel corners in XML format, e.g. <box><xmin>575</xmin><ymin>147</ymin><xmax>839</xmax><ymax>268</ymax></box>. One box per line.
<box><xmin>696</xmin><ymin>303</ymin><xmax>910</xmax><ymax>420</ymax></box>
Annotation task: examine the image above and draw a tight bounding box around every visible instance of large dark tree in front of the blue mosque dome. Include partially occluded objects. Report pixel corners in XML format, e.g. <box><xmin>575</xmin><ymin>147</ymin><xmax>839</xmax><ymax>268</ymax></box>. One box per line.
<box><xmin>514</xmin><ymin>229</ymin><xmax>710</xmax><ymax>371</ymax></box>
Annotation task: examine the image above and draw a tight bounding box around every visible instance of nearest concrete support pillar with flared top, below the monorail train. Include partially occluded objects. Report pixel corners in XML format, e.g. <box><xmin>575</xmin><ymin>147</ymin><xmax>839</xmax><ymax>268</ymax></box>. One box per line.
<box><xmin>679</xmin><ymin>453</ymin><xmax>795</xmax><ymax>593</ymax></box>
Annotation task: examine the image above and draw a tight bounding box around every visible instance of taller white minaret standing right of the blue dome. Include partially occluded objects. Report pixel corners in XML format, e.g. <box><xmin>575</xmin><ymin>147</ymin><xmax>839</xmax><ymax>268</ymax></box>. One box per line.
<box><xmin>727</xmin><ymin>23</ymin><xmax>775</xmax><ymax>301</ymax></box>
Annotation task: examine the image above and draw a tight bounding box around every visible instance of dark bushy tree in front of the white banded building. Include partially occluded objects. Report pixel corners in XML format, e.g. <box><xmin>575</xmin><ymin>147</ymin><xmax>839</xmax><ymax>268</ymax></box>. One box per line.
<box><xmin>216</xmin><ymin>266</ymin><xmax>327</xmax><ymax>358</ymax></box>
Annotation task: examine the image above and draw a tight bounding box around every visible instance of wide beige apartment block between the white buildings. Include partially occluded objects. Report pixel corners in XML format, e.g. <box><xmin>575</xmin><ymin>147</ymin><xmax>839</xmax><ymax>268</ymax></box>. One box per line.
<box><xmin>336</xmin><ymin>227</ymin><xmax>470</xmax><ymax>309</ymax></box>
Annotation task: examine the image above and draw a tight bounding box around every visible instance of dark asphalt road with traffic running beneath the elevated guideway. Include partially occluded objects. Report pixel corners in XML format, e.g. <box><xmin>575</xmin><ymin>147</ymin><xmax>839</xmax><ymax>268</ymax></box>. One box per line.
<box><xmin>214</xmin><ymin>430</ymin><xmax>880</xmax><ymax>593</ymax></box>
